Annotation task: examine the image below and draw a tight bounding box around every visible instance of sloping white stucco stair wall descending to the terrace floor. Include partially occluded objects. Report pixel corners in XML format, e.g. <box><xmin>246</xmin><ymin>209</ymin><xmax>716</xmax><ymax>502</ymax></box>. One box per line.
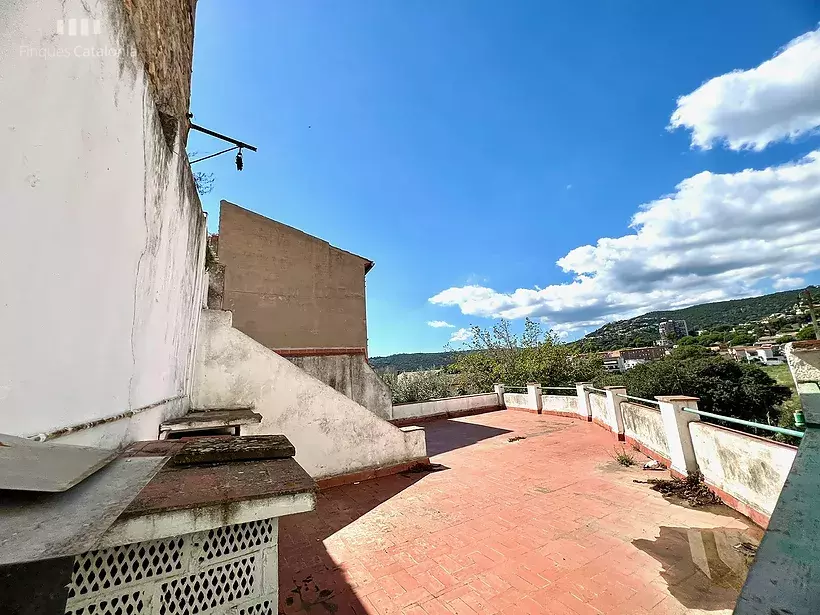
<box><xmin>192</xmin><ymin>310</ymin><xmax>427</xmax><ymax>478</ymax></box>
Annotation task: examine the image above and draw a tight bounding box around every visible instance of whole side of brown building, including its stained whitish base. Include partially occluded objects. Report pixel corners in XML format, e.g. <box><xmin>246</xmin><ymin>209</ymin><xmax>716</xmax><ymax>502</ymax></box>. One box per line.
<box><xmin>210</xmin><ymin>201</ymin><xmax>392</xmax><ymax>418</ymax></box>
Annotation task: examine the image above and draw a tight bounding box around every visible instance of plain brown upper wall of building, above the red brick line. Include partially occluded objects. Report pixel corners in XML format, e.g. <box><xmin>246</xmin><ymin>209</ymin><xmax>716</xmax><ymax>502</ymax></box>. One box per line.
<box><xmin>219</xmin><ymin>201</ymin><xmax>368</xmax><ymax>349</ymax></box>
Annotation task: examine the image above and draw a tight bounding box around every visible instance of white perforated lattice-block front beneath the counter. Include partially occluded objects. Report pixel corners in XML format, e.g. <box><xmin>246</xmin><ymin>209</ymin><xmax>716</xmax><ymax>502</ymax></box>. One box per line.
<box><xmin>65</xmin><ymin>518</ymin><xmax>278</xmax><ymax>615</ymax></box>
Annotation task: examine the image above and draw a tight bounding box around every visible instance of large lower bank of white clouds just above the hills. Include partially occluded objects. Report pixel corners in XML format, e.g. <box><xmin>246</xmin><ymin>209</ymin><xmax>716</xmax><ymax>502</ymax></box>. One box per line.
<box><xmin>429</xmin><ymin>151</ymin><xmax>820</xmax><ymax>333</ymax></box>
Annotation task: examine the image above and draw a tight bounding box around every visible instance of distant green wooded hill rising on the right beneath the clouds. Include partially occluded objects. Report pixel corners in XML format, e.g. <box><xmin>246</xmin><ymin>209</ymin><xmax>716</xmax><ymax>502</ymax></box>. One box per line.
<box><xmin>584</xmin><ymin>290</ymin><xmax>812</xmax><ymax>350</ymax></box>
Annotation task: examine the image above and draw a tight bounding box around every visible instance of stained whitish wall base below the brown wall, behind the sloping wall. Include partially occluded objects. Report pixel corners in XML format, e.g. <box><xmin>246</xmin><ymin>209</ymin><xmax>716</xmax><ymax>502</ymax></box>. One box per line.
<box><xmin>285</xmin><ymin>354</ymin><xmax>393</xmax><ymax>420</ymax></box>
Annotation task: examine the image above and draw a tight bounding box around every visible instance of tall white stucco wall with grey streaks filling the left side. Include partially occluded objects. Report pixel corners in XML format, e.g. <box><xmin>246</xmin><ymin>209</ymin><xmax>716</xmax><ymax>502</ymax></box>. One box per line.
<box><xmin>0</xmin><ymin>0</ymin><xmax>205</xmax><ymax>444</ymax></box>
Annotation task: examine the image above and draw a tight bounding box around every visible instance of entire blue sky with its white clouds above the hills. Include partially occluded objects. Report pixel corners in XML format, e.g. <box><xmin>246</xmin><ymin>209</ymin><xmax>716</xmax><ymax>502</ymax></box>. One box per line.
<box><xmin>189</xmin><ymin>0</ymin><xmax>820</xmax><ymax>355</ymax></box>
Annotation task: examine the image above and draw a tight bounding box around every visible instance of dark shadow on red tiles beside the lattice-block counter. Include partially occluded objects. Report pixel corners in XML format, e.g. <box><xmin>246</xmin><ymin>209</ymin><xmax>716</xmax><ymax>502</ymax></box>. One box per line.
<box><xmin>279</xmin><ymin>472</ymin><xmax>427</xmax><ymax>615</ymax></box>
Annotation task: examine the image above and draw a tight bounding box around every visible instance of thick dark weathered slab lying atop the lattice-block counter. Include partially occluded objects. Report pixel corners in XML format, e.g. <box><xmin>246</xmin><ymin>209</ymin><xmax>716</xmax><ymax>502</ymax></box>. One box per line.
<box><xmin>172</xmin><ymin>435</ymin><xmax>296</xmax><ymax>465</ymax></box>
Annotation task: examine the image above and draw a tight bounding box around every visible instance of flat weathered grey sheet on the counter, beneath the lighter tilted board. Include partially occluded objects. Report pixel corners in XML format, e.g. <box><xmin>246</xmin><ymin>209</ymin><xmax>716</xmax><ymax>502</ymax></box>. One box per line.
<box><xmin>0</xmin><ymin>457</ymin><xmax>168</xmax><ymax>565</ymax></box>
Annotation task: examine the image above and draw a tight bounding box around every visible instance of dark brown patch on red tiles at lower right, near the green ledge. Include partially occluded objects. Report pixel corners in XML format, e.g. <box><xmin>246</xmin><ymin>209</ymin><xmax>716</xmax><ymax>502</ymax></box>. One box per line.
<box><xmin>632</xmin><ymin>526</ymin><xmax>751</xmax><ymax>611</ymax></box>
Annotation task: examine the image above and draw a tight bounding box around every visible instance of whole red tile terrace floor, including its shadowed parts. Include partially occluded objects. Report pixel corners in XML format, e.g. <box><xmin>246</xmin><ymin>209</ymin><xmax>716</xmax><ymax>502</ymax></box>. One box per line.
<box><xmin>279</xmin><ymin>411</ymin><xmax>762</xmax><ymax>615</ymax></box>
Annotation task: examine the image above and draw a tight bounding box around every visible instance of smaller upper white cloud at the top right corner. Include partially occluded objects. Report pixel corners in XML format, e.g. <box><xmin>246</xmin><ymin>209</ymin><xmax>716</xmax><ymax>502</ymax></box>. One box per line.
<box><xmin>669</xmin><ymin>29</ymin><xmax>820</xmax><ymax>150</ymax></box>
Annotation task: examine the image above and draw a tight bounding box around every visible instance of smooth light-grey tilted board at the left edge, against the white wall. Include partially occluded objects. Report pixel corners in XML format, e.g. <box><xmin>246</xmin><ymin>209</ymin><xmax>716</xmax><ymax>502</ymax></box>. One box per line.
<box><xmin>0</xmin><ymin>434</ymin><xmax>117</xmax><ymax>492</ymax></box>
